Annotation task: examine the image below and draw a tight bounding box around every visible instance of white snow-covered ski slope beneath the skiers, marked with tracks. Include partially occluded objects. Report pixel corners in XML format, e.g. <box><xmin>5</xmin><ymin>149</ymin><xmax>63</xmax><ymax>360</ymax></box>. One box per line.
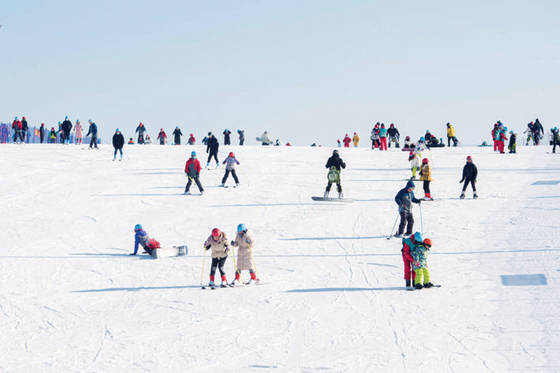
<box><xmin>0</xmin><ymin>145</ymin><xmax>560</xmax><ymax>373</ymax></box>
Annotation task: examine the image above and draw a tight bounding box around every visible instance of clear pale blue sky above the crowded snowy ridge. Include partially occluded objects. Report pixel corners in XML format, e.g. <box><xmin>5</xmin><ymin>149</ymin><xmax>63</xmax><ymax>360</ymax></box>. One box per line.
<box><xmin>0</xmin><ymin>0</ymin><xmax>560</xmax><ymax>145</ymax></box>
